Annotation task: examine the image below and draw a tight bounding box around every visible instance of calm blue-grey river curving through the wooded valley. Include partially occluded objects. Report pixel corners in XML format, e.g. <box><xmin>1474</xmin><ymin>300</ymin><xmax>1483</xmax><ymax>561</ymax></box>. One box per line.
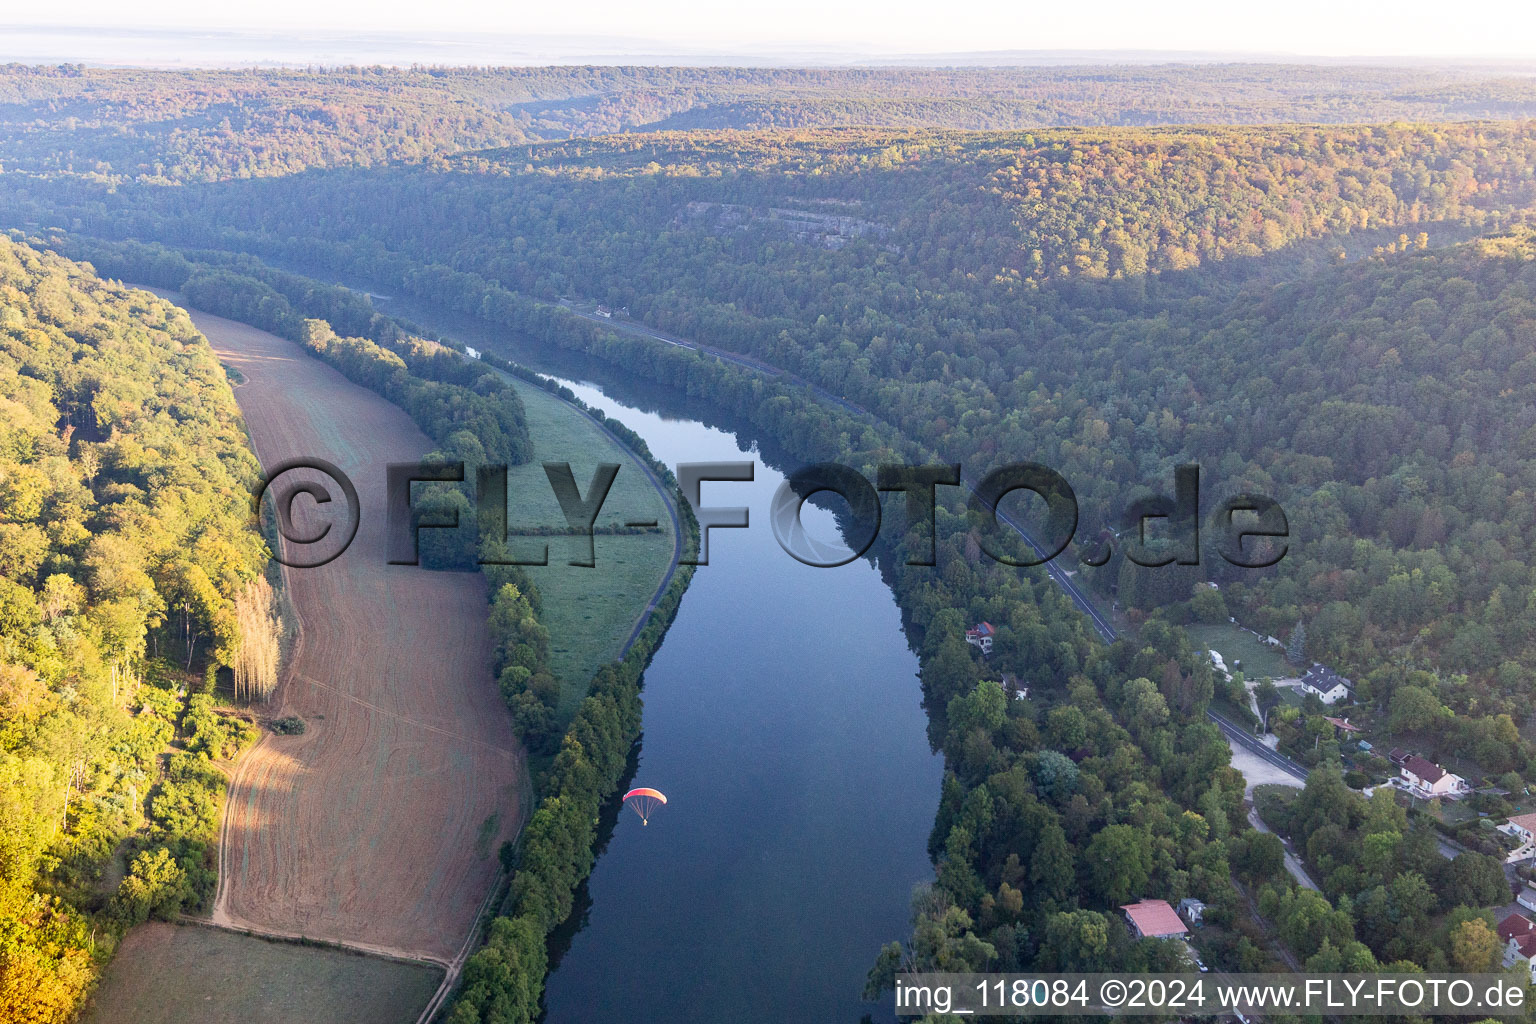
<box><xmin>368</xmin><ymin>291</ymin><xmax>943</xmax><ymax>1024</ymax></box>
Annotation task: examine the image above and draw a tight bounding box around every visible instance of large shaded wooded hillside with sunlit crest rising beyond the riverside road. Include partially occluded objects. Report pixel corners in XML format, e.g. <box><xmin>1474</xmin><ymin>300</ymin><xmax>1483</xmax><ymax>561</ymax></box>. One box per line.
<box><xmin>33</xmin><ymin>126</ymin><xmax>1536</xmax><ymax>712</ymax></box>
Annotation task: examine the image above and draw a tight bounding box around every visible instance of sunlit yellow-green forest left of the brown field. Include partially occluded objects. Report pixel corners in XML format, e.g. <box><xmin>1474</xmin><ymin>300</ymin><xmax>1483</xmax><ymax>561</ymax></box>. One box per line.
<box><xmin>0</xmin><ymin>239</ymin><xmax>267</xmax><ymax>1022</ymax></box>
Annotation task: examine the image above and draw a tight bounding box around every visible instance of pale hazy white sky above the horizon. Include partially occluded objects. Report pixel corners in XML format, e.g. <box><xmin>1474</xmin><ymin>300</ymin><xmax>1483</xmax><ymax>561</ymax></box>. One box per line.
<box><xmin>9</xmin><ymin>0</ymin><xmax>1536</xmax><ymax>58</ymax></box>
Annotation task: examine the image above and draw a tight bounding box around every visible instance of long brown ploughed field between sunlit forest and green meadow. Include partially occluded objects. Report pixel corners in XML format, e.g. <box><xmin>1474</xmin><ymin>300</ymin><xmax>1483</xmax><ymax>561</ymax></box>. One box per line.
<box><xmin>178</xmin><ymin>313</ymin><xmax>525</xmax><ymax>964</ymax></box>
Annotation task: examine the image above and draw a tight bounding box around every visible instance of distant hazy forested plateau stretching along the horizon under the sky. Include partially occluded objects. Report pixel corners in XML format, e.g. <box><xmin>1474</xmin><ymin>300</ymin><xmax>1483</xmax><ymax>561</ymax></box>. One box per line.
<box><xmin>0</xmin><ymin>64</ymin><xmax>1536</xmax><ymax>184</ymax></box>
